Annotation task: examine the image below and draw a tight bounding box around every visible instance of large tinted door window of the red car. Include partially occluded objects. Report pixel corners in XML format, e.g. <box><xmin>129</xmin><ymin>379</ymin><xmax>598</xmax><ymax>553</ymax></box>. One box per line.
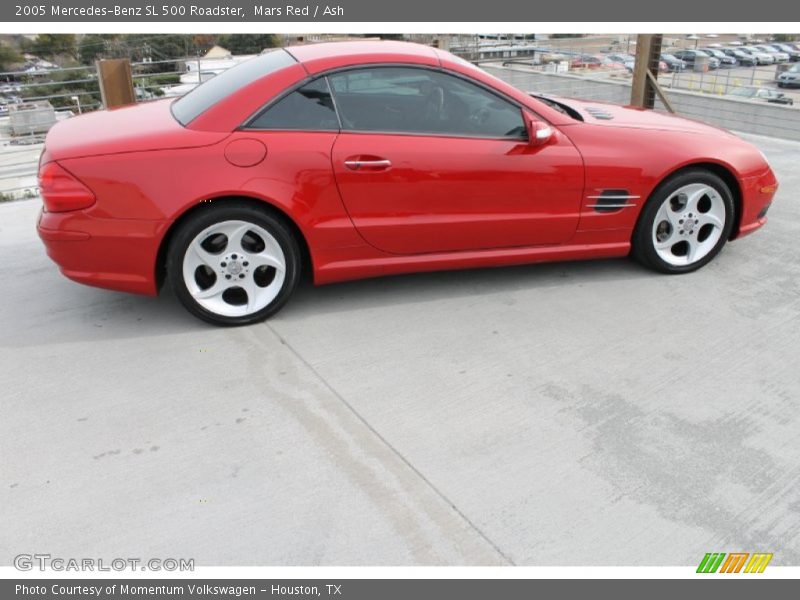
<box><xmin>328</xmin><ymin>67</ymin><xmax>527</xmax><ymax>139</ymax></box>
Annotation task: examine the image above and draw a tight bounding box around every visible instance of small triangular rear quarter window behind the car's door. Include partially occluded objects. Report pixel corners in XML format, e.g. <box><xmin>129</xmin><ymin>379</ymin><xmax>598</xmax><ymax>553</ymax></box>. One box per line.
<box><xmin>248</xmin><ymin>77</ymin><xmax>339</xmax><ymax>131</ymax></box>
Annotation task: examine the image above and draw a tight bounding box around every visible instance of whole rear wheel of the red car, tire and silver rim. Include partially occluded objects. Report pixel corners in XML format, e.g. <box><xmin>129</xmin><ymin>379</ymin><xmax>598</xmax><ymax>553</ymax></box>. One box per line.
<box><xmin>167</xmin><ymin>201</ymin><xmax>300</xmax><ymax>325</ymax></box>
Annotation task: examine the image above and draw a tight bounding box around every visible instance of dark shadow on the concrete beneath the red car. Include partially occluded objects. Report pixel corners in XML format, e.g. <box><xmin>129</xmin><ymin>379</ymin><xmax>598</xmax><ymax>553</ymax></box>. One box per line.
<box><xmin>0</xmin><ymin>253</ymin><xmax>654</xmax><ymax>348</ymax></box>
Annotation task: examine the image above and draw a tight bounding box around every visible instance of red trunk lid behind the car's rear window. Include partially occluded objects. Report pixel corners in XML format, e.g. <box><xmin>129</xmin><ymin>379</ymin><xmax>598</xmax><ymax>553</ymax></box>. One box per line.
<box><xmin>45</xmin><ymin>99</ymin><xmax>229</xmax><ymax>160</ymax></box>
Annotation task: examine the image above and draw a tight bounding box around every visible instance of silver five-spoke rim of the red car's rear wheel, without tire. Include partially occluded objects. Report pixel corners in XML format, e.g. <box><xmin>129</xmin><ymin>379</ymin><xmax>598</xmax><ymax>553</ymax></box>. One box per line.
<box><xmin>183</xmin><ymin>221</ymin><xmax>286</xmax><ymax>317</ymax></box>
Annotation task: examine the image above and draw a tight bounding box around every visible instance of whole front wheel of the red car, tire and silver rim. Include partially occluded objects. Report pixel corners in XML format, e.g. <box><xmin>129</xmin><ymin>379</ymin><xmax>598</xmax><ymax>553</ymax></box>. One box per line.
<box><xmin>633</xmin><ymin>169</ymin><xmax>734</xmax><ymax>273</ymax></box>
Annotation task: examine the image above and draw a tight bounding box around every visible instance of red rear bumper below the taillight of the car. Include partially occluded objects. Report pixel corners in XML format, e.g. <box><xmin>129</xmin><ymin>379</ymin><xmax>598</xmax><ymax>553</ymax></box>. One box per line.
<box><xmin>36</xmin><ymin>210</ymin><xmax>169</xmax><ymax>295</ymax></box>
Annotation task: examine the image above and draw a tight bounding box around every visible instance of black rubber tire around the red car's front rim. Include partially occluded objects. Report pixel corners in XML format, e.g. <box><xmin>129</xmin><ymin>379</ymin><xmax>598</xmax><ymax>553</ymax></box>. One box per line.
<box><xmin>631</xmin><ymin>169</ymin><xmax>736</xmax><ymax>274</ymax></box>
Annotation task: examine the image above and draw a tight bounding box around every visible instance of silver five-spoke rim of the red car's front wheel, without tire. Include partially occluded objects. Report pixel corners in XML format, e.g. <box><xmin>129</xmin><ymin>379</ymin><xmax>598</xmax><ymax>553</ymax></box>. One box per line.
<box><xmin>652</xmin><ymin>183</ymin><xmax>727</xmax><ymax>267</ymax></box>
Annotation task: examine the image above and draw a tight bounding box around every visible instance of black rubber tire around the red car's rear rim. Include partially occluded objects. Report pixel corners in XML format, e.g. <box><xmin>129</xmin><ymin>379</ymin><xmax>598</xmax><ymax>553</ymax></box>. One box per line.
<box><xmin>166</xmin><ymin>200</ymin><xmax>302</xmax><ymax>326</ymax></box>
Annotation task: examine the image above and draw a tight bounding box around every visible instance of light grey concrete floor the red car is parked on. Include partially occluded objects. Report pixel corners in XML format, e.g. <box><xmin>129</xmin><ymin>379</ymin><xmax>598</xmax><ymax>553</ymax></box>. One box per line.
<box><xmin>0</xmin><ymin>132</ymin><xmax>800</xmax><ymax>565</ymax></box>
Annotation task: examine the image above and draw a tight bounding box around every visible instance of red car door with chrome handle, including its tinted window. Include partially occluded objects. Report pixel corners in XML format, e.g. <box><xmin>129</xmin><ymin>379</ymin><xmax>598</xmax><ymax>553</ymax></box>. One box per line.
<box><xmin>329</xmin><ymin>66</ymin><xmax>583</xmax><ymax>254</ymax></box>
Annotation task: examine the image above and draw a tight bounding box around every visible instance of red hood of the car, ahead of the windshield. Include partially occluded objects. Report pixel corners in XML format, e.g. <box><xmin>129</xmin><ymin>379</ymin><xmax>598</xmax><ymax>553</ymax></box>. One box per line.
<box><xmin>548</xmin><ymin>96</ymin><xmax>736</xmax><ymax>137</ymax></box>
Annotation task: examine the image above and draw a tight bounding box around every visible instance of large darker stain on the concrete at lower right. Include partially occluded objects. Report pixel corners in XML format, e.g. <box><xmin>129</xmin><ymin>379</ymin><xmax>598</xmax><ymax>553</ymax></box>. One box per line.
<box><xmin>540</xmin><ymin>384</ymin><xmax>800</xmax><ymax>564</ymax></box>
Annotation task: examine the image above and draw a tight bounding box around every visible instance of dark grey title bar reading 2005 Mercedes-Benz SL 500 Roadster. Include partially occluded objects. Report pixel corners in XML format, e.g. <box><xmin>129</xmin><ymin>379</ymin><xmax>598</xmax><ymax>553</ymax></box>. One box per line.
<box><xmin>0</xmin><ymin>0</ymin><xmax>800</xmax><ymax>22</ymax></box>
